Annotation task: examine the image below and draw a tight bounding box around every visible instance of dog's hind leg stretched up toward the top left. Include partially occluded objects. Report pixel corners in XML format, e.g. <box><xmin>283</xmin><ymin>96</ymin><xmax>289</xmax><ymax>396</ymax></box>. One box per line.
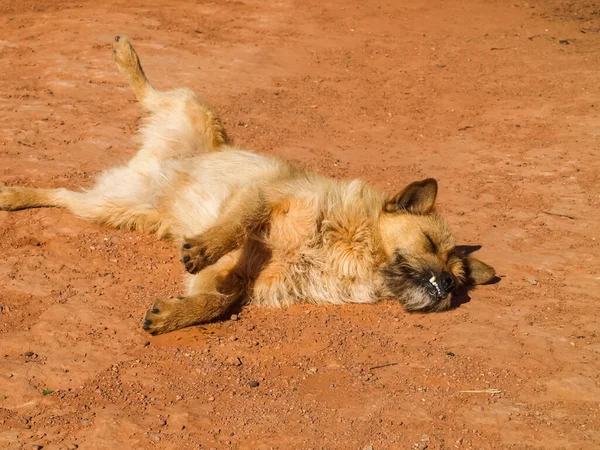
<box><xmin>113</xmin><ymin>36</ymin><xmax>229</xmax><ymax>159</ymax></box>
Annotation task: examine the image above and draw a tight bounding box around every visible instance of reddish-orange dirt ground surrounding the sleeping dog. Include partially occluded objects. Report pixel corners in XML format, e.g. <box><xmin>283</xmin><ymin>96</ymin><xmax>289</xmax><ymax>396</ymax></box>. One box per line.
<box><xmin>0</xmin><ymin>0</ymin><xmax>600</xmax><ymax>450</ymax></box>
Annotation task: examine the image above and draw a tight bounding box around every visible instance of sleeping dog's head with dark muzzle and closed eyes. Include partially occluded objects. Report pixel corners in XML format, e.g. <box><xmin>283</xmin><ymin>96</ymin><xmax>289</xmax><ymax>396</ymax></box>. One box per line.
<box><xmin>380</xmin><ymin>178</ymin><xmax>495</xmax><ymax>311</ymax></box>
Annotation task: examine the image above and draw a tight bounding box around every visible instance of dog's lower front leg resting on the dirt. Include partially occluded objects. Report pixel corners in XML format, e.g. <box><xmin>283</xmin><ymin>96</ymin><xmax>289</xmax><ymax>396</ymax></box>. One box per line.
<box><xmin>144</xmin><ymin>250</ymin><xmax>246</xmax><ymax>334</ymax></box>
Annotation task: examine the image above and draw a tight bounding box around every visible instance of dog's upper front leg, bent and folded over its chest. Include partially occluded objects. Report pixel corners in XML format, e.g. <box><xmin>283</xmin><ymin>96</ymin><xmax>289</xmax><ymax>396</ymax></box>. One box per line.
<box><xmin>181</xmin><ymin>187</ymin><xmax>268</xmax><ymax>273</ymax></box>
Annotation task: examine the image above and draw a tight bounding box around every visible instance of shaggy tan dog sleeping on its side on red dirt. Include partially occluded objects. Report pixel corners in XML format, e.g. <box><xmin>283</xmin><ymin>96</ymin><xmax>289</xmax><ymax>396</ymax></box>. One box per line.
<box><xmin>0</xmin><ymin>36</ymin><xmax>495</xmax><ymax>334</ymax></box>
